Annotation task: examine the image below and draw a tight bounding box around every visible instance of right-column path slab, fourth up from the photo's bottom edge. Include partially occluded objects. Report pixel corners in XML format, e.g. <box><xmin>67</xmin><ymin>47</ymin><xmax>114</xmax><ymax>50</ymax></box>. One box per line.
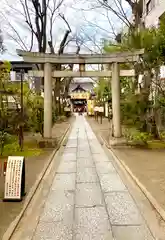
<box><xmin>96</xmin><ymin>162</ymin><xmax>116</xmax><ymax>174</ymax></box>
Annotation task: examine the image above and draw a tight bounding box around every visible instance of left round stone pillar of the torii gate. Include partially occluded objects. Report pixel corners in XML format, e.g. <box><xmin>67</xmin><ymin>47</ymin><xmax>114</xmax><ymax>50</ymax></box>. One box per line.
<box><xmin>44</xmin><ymin>63</ymin><xmax>52</xmax><ymax>138</ymax></box>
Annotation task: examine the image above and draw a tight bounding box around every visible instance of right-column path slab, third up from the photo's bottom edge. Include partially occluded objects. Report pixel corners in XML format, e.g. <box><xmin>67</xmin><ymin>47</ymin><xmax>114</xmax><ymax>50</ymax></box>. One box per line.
<box><xmin>99</xmin><ymin>173</ymin><xmax>127</xmax><ymax>193</ymax></box>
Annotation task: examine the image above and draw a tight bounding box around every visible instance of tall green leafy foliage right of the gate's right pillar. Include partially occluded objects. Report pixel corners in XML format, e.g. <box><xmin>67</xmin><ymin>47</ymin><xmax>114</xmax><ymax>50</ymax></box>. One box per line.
<box><xmin>100</xmin><ymin>18</ymin><xmax>165</xmax><ymax>142</ymax></box>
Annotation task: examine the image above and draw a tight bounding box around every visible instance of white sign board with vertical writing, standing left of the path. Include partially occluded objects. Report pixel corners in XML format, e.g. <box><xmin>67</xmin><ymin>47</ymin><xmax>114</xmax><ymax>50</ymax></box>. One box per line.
<box><xmin>3</xmin><ymin>156</ymin><xmax>25</xmax><ymax>201</ymax></box>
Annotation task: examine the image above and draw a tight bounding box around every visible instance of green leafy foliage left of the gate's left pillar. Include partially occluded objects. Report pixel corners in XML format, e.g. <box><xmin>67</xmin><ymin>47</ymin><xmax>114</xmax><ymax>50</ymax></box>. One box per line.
<box><xmin>0</xmin><ymin>62</ymin><xmax>57</xmax><ymax>155</ymax></box>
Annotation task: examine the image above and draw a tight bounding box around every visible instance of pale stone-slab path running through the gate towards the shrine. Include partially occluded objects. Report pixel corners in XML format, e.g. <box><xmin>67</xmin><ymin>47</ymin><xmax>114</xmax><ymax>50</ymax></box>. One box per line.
<box><xmin>33</xmin><ymin>116</ymin><xmax>153</xmax><ymax>240</ymax></box>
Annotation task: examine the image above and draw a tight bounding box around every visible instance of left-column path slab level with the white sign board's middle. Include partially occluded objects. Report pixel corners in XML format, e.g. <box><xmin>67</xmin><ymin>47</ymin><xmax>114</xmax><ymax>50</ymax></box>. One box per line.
<box><xmin>51</xmin><ymin>173</ymin><xmax>76</xmax><ymax>191</ymax></box>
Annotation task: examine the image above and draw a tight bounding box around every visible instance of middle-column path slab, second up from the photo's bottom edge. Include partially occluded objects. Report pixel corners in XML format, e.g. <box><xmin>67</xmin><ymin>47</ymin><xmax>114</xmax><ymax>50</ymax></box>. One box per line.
<box><xmin>76</xmin><ymin>183</ymin><xmax>104</xmax><ymax>207</ymax></box>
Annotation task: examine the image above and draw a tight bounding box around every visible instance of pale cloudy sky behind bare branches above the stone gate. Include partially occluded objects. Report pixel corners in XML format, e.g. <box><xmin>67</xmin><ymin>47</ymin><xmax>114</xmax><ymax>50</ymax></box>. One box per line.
<box><xmin>0</xmin><ymin>0</ymin><xmax>129</xmax><ymax>61</ymax></box>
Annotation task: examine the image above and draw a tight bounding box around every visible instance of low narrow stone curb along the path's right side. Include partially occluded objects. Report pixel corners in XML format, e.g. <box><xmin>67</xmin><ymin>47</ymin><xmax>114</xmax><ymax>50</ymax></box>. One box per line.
<box><xmin>99</xmin><ymin>136</ymin><xmax>165</xmax><ymax>221</ymax></box>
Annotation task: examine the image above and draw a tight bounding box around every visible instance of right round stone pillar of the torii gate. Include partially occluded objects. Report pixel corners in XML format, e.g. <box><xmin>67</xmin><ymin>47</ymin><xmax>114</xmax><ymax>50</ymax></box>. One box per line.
<box><xmin>111</xmin><ymin>63</ymin><xmax>122</xmax><ymax>138</ymax></box>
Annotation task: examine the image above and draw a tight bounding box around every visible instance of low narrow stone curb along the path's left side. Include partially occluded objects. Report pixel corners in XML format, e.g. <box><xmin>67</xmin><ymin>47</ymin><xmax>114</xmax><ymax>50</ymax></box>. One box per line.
<box><xmin>2</xmin><ymin>124</ymin><xmax>71</xmax><ymax>240</ymax></box>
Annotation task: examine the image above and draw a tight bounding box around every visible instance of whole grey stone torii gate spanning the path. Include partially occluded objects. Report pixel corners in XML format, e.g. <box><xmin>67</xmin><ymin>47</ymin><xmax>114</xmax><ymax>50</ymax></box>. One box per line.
<box><xmin>17</xmin><ymin>50</ymin><xmax>144</xmax><ymax>138</ymax></box>
